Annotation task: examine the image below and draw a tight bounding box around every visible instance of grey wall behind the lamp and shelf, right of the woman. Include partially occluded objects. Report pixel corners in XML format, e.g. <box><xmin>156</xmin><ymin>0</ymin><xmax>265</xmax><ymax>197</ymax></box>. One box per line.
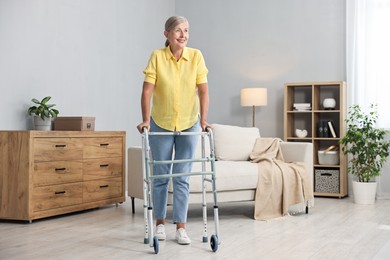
<box><xmin>176</xmin><ymin>0</ymin><xmax>346</xmax><ymax>137</ymax></box>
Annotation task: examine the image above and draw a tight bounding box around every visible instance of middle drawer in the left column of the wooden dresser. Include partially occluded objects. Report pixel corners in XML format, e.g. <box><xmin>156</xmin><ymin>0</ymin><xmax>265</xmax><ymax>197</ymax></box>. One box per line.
<box><xmin>33</xmin><ymin>161</ymin><xmax>83</xmax><ymax>186</ymax></box>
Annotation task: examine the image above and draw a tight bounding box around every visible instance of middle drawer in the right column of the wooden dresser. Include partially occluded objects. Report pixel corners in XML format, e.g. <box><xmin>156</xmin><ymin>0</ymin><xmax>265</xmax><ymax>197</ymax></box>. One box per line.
<box><xmin>83</xmin><ymin>157</ymin><xmax>123</xmax><ymax>181</ymax></box>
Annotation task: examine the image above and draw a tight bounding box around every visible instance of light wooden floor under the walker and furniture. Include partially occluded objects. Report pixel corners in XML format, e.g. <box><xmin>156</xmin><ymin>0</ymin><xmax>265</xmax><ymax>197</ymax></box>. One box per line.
<box><xmin>0</xmin><ymin>198</ymin><xmax>390</xmax><ymax>260</ymax></box>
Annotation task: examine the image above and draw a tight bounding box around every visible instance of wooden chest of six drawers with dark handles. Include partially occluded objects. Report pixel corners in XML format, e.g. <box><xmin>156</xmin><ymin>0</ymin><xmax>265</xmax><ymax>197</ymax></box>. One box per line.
<box><xmin>0</xmin><ymin>131</ymin><xmax>126</xmax><ymax>221</ymax></box>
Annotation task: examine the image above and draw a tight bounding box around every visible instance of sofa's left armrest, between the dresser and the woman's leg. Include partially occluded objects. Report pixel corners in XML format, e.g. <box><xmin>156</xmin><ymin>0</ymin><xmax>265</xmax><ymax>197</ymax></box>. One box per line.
<box><xmin>127</xmin><ymin>146</ymin><xmax>144</xmax><ymax>199</ymax></box>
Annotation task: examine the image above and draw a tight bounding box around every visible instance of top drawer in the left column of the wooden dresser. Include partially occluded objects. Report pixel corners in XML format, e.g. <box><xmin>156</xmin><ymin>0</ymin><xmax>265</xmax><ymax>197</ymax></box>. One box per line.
<box><xmin>33</xmin><ymin>138</ymin><xmax>83</xmax><ymax>162</ymax></box>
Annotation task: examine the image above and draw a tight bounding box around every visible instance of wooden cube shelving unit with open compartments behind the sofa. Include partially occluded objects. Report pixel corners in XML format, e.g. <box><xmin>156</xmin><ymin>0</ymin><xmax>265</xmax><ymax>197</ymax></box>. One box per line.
<box><xmin>284</xmin><ymin>81</ymin><xmax>348</xmax><ymax>198</ymax></box>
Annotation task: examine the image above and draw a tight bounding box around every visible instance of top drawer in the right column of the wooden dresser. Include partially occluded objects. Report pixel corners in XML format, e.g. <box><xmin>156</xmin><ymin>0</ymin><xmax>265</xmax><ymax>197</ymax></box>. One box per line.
<box><xmin>83</xmin><ymin>137</ymin><xmax>123</xmax><ymax>158</ymax></box>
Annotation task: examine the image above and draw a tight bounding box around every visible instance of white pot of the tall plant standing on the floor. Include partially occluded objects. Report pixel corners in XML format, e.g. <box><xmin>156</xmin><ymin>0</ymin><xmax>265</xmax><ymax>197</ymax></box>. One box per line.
<box><xmin>352</xmin><ymin>181</ymin><xmax>377</xmax><ymax>205</ymax></box>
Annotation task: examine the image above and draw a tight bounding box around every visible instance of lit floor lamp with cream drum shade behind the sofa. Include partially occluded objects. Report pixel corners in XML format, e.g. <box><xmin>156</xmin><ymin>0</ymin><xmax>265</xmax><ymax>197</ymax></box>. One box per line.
<box><xmin>241</xmin><ymin>88</ymin><xmax>267</xmax><ymax>127</ymax></box>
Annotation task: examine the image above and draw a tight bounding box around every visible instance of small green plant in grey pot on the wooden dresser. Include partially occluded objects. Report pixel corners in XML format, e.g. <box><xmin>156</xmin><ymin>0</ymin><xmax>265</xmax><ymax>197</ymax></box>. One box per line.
<box><xmin>28</xmin><ymin>96</ymin><xmax>59</xmax><ymax>131</ymax></box>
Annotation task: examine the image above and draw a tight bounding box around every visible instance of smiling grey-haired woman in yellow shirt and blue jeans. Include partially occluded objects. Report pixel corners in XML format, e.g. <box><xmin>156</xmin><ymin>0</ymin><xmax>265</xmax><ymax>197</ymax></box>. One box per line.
<box><xmin>137</xmin><ymin>16</ymin><xmax>209</xmax><ymax>245</ymax></box>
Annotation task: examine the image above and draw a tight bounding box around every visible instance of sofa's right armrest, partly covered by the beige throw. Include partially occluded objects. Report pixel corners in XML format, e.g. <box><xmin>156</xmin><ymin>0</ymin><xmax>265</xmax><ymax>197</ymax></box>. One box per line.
<box><xmin>281</xmin><ymin>142</ymin><xmax>314</xmax><ymax>185</ymax></box>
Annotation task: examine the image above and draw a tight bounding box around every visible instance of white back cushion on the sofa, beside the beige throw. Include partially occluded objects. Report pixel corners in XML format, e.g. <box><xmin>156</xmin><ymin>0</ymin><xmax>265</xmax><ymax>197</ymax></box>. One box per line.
<box><xmin>212</xmin><ymin>124</ymin><xmax>260</xmax><ymax>161</ymax></box>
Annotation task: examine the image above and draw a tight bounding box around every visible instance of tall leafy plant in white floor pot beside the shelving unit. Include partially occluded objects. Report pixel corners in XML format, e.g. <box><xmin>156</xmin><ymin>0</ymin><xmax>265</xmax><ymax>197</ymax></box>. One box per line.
<box><xmin>340</xmin><ymin>104</ymin><xmax>390</xmax><ymax>204</ymax></box>
